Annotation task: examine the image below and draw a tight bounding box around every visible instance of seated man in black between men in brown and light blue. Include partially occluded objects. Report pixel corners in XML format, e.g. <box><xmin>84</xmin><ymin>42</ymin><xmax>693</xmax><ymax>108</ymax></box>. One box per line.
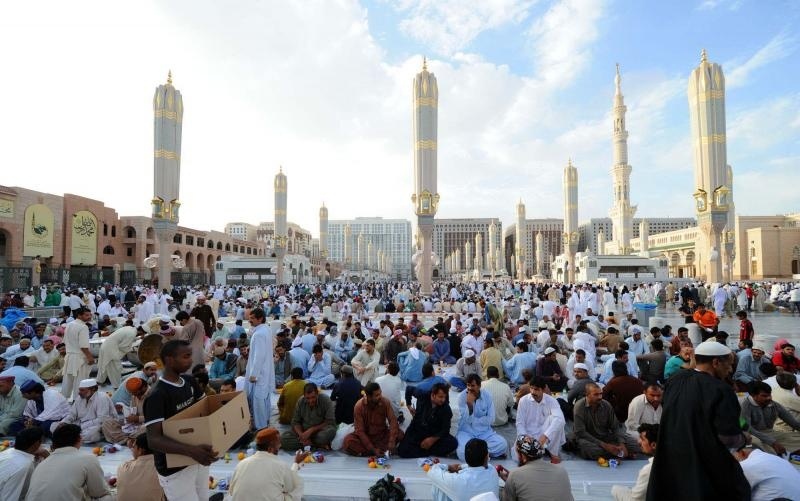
<box><xmin>398</xmin><ymin>383</ymin><xmax>458</xmax><ymax>458</ymax></box>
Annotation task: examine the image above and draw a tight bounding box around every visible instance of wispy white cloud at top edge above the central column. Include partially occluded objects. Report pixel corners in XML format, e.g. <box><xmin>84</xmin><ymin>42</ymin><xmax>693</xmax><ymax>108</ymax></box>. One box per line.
<box><xmin>396</xmin><ymin>0</ymin><xmax>535</xmax><ymax>56</ymax></box>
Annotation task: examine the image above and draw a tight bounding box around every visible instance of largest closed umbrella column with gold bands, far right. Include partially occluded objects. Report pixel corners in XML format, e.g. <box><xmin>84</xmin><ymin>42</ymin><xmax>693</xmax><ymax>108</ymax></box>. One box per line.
<box><xmin>688</xmin><ymin>49</ymin><xmax>731</xmax><ymax>283</ymax></box>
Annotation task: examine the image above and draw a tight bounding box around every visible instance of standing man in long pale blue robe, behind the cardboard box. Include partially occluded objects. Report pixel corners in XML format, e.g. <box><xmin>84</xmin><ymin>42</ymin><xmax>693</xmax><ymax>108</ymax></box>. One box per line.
<box><xmin>245</xmin><ymin>308</ymin><xmax>275</xmax><ymax>430</ymax></box>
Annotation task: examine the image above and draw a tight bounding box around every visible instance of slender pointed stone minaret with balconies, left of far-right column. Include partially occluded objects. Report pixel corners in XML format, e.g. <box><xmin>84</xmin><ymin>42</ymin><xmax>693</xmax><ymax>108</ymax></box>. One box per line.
<box><xmin>608</xmin><ymin>64</ymin><xmax>636</xmax><ymax>255</ymax></box>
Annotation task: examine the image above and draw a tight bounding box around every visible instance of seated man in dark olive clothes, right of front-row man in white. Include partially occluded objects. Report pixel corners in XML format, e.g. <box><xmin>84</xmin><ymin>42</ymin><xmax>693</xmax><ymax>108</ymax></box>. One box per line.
<box><xmin>571</xmin><ymin>383</ymin><xmax>639</xmax><ymax>460</ymax></box>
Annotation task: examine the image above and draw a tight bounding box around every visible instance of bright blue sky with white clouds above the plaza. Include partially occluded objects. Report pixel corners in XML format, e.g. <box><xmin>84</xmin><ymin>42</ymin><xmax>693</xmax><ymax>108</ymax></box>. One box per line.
<box><xmin>0</xmin><ymin>0</ymin><xmax>800</xmax><ymax>234</ymax></box>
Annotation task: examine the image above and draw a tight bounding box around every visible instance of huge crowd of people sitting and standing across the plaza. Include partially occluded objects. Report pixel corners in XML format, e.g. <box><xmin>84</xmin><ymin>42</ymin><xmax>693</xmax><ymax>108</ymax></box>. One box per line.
<box><xmin>0</xmin><ymin>282</ymin><xmax>800</xmax><ymax>501</ymax></box>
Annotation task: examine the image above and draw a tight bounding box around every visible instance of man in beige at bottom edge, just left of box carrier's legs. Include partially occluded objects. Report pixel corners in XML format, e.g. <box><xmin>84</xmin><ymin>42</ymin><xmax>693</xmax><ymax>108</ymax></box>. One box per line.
<box><xmin>116</xmin><ymin>433</ymin><xmax>164</xmax><ymax>501</ymax></box>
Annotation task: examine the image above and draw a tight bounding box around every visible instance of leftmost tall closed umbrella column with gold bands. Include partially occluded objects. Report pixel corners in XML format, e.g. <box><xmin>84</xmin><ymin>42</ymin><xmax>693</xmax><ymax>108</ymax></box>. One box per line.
<box><xmin>151</xmin><ymin>71</ymin><xmax>183</xmax><ymax>290</ymax></box>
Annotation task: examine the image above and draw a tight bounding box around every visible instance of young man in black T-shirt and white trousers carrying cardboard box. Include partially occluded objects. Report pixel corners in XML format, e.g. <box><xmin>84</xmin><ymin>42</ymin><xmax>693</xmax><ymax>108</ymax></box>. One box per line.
<box><xmin>144</xmin><ymin>340</ymin><xmax>217</xmax><ymax>501</ymax></box>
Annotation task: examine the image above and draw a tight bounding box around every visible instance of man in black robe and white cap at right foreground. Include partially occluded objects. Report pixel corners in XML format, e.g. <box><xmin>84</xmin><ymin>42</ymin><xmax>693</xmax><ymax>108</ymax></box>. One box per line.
<box><xmin>647</xmin><ymin>340</ymin><xmax>750</xmax><ymax>501</ymax></box>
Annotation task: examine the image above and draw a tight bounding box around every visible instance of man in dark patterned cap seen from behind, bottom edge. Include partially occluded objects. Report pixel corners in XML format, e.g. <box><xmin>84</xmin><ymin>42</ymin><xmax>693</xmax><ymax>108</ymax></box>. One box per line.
<box><xmin>499</xmin><ymin>435</ymin><xmax>573</xmax><ymax>501</ymax></box>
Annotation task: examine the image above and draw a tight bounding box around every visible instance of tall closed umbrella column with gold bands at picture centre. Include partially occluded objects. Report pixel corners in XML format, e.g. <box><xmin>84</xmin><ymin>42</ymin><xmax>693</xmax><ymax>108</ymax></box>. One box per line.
<box><xmin>411</xmin><ymin>59</ymin><xmax>439</xmax><ymax>295</ymax></box>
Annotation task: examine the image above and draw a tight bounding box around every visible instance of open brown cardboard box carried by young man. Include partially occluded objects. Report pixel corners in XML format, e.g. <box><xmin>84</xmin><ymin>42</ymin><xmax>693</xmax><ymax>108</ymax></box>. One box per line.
<box><xmin>162</xmin><ymin>391</ymin><xmax>250</xmax><ymax>468</ymax></box>
